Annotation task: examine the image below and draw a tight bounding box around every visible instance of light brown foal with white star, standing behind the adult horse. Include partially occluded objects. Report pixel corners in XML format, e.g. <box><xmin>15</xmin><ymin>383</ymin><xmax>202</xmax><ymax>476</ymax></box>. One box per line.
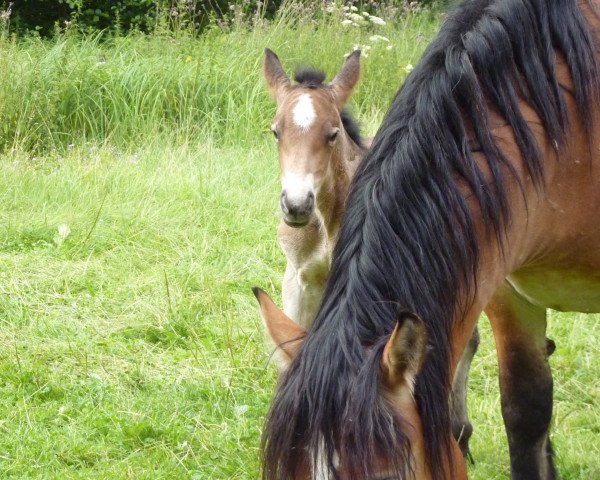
<box><xmin>263</xmin><ymin>49</ymin><xmax>370</xmax><ymax>328</ymax></box>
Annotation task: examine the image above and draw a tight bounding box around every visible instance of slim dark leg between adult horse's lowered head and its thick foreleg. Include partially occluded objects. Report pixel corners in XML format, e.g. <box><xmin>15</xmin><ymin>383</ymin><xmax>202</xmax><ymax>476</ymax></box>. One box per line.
<box><xmin>450</xmin><ymin>327</ymin><xmax>479</xmax><ymax>462</ymax></box>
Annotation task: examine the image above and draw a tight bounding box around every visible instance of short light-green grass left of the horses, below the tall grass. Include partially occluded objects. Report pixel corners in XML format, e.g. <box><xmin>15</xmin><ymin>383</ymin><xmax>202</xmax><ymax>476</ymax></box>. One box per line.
<box><xmin>0</xmin><ymin>142</ymin><xmax>282</xmax><ymax>479</ymax></box>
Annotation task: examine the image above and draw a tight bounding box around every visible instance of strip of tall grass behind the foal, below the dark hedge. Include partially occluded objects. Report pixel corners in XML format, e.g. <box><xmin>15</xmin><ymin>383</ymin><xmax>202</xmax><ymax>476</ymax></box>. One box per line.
<box><xmin>0</xmin><ymin>3</ymin><xmax>436</xmax><ymax>153</ymax></box>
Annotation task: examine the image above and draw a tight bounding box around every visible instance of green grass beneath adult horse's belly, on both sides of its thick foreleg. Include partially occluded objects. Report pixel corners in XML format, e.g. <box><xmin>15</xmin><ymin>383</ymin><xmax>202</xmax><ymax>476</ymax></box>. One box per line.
<box><xmin>468</xmin><ymin>310</ymin><xmax>600</xmax><ymax>480</ymax></box>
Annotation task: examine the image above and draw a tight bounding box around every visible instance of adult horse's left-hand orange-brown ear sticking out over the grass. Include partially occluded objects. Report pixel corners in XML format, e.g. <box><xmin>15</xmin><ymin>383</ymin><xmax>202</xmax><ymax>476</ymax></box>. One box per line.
<box><xmin>252</xmin><ymin>287</ymin><xmax>306</xmax><ymax>370</ymax></box>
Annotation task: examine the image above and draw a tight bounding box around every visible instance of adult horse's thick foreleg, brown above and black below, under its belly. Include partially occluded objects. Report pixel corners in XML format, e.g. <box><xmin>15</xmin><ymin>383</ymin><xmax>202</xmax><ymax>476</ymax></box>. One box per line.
<box><xmin>485</xmin><ymin>282</ymin><xmax>556</xmax><ymax>480</ymax></box>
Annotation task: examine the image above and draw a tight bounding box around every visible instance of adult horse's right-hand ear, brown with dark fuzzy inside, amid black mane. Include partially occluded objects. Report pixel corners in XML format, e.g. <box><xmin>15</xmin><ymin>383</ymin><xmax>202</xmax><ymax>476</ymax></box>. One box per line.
<box><xmin>382</xmin><ymin>312</ymin><xmax>427</xmax><ymax>389</ymax></box>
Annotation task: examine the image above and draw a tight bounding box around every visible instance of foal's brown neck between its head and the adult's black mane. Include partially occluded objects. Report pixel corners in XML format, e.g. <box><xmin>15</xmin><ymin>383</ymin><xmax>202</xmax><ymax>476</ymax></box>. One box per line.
<box><xmin>317</xmin><ymin>135</ymin><xmax>364</xmax><ymax>245</ymax></box>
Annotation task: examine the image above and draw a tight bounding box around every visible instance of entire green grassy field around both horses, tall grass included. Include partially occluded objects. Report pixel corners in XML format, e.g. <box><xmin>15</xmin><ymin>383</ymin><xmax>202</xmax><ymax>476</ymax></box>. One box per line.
<box><xmin>0</xmin><ymin>0</ymin><xmax>600</xmax><ymax>480</ymax></box>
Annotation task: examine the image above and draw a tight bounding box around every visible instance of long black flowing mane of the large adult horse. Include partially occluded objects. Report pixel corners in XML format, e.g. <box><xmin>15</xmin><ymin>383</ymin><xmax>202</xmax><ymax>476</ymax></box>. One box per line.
<box><xmin>263</xmin><ymin>0</ymin><xmax>600</xmax><ymax>480</ymax></box>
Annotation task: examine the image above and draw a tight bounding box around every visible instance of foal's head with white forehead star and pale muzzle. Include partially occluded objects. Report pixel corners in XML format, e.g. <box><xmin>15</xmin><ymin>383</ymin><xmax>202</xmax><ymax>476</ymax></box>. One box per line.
<box><xmin>264</xmin><ymin>49</ymin><xmax>360</xmax><ymax>227</ymax></box>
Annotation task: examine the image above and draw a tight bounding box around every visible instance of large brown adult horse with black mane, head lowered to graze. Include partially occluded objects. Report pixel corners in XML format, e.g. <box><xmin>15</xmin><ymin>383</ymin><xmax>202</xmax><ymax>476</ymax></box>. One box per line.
<box><xmin>257</xmin><ymin>0</ymin><xmax>600</xmax><ymax>480</ymax></box>
